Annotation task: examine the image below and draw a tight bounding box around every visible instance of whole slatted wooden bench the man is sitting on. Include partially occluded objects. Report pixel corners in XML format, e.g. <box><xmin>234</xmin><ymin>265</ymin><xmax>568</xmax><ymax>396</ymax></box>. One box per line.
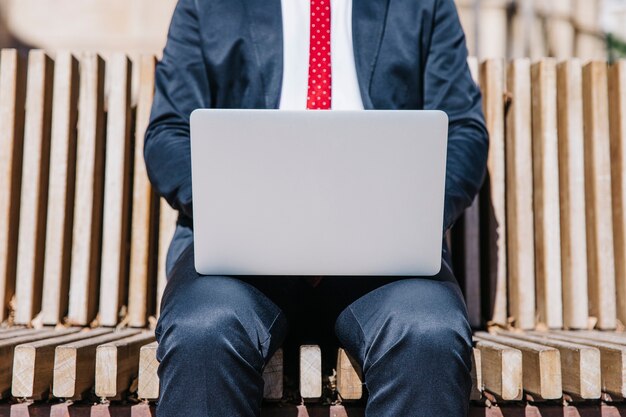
<box><xmin>0</xmin><ymin>50</ymin><xmax>626</xmax><ymax>416</ymax></box>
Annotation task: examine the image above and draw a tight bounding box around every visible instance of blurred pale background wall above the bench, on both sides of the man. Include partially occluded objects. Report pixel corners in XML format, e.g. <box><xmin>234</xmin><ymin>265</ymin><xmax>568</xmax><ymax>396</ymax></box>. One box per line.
<box><xmin>0</xmin><ymin>0</ymin><xmax>626</xmax><ymax>58</ymax></box>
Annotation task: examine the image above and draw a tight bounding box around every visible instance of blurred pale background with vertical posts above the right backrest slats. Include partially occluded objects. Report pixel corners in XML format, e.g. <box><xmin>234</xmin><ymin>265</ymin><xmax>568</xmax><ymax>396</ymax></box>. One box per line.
<box><xmin>456</xmin><ymin>0</ymin><xmax>626</xmax><ymax>59</ymax></box>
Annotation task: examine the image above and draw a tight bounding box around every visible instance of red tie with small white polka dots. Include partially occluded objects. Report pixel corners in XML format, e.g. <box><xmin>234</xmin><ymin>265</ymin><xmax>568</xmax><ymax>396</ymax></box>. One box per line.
<box><xmin>306</xmin><ymin>0</ymin><xmax>332</xmax><ymax>110</ymax></box>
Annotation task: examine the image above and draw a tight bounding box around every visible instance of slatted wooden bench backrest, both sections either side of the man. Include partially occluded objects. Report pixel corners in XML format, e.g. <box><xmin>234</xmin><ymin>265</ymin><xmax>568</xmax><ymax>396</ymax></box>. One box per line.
<box><xmin>0</xmin><ymin>50</ymin><xmax>626</xmax><ymax>329</ymax></box>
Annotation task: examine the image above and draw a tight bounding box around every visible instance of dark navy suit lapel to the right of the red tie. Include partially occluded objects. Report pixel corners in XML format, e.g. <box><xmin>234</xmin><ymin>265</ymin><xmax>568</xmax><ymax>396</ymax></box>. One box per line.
<box><xmin>352</xmin><ymin>0</ymin><xmax>389</xmax><ymax>109</ymax></box>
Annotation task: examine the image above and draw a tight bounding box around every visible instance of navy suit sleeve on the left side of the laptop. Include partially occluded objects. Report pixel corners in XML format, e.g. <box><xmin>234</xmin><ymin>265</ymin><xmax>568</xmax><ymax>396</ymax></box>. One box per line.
<box><xmin>144</xmin><ymin>0</ymin><xmax>211</xmax><ymax>219</ymax></box>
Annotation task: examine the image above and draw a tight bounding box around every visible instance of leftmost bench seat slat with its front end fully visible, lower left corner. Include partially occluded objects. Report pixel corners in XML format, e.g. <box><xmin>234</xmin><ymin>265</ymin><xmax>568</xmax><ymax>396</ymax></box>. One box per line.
<box><xmin>11</xmin><ymin>329</ymin><xmax>111</xmax><ymax>400</ymax></box>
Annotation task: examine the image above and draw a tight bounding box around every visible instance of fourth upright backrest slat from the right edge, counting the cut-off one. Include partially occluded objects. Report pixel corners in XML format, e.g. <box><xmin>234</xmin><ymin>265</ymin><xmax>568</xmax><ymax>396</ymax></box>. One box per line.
<box><xmin>531</xmin><ymin>59</ymin><xmax>563</xmax><ymax>329</ymax></box>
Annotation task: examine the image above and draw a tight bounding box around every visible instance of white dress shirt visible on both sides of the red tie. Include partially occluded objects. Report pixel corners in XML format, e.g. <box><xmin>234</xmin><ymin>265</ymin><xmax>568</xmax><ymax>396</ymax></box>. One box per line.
<box><xmin>279</xmin><ymin>0</ymin><xmax>363</xmax><ymax>110</ymax></box>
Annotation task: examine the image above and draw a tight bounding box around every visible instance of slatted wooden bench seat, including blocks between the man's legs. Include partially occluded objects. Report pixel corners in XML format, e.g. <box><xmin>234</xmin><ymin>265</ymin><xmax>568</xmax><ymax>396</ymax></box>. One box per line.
<box><xmin>0</xmin><ymin>327</ymin><xmax>626</xmax><ymax>403</ymax></box>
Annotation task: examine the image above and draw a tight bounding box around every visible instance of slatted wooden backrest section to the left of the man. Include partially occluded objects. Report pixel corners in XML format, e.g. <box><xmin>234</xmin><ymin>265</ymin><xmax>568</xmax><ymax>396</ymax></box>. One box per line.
<box><xmin>0</xmin><ymin>50</ymin><xmax>176</xmax><ymax>326</ymax></box>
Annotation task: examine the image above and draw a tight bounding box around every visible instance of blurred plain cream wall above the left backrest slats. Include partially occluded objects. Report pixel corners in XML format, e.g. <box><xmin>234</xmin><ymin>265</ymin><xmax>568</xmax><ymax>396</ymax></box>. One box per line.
<box><xmin>0</xmin><ymin>0</ymin><xmax>176</xmax><ymax>55</ymax></box>
